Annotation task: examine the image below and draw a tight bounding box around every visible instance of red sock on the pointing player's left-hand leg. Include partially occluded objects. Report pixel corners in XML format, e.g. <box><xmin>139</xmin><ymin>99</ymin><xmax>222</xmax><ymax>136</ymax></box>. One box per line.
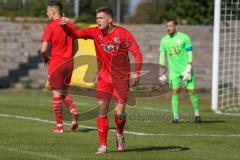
<box><xmin>97</xmin><ymin>116</ymin><xmax>109</xmax><ymax>146</ymax></box>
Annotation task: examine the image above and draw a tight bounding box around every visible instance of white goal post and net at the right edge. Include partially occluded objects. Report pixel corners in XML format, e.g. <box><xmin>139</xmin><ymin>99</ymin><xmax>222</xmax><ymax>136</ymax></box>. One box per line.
<box><xmin>212</xmin><ymin>0</ymin><xmax>240</xmax><ymax>115</ymax></box>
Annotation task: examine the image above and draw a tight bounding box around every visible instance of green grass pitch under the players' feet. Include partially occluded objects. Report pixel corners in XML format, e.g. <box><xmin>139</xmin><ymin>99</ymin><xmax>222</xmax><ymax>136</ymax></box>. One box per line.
<box><xmin>0</xmin><ymin>90</ymin><xmax>240</xmax><ymax>160</ymax></box>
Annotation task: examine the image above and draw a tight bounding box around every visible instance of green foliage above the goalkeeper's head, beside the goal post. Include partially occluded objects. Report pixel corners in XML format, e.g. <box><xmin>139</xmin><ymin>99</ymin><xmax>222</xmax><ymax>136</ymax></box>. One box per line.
<box><xmin>130</xmin><ymin>0</ymin><xmax>214</xmax><ymax>25</ymax></box>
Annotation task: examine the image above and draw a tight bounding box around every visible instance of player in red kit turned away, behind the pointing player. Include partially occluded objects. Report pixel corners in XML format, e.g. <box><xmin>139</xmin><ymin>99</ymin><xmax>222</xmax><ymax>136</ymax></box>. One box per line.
<box><xmin>41</xmin><ymin>1</ymin><xmax>79</xmax><ymax>133</ymax></box>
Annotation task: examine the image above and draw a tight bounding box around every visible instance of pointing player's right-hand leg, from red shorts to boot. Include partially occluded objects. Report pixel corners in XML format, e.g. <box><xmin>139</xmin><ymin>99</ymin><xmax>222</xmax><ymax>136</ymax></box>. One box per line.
<box><xmin>113</xmin><ymin>81</ymin><xmax>129</xmax><ymax>151</ymax></box>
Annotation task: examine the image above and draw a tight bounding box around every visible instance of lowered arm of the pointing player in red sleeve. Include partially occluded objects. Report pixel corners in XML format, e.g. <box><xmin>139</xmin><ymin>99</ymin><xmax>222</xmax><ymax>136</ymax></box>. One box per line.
<box><xmin>129</xmin><ymin>34</ymin><xmax>142</xmax><ymax>86</ymax></box>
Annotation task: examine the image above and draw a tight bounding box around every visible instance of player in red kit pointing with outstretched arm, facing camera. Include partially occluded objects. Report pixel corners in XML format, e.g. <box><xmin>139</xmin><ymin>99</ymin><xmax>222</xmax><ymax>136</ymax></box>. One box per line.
<box><xmin>61</xmin><ymin>7</ymin><xmax>142</xmax><ymax>154</ymax></box>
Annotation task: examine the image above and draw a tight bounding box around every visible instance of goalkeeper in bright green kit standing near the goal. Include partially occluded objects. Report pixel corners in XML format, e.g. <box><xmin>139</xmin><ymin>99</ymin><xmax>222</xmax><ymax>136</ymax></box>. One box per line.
<box><xmin>159</xmin><ymin>19</ymin><xmax>201</xmax><ymax>123</ymax></box>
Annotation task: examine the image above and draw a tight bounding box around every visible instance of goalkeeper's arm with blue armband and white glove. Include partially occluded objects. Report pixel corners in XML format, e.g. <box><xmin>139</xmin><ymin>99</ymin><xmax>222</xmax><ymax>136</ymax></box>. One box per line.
<box><xmin>182</xmin><ymin>36</ymin><xmax>193</xmax><ymax>80</ymax></box>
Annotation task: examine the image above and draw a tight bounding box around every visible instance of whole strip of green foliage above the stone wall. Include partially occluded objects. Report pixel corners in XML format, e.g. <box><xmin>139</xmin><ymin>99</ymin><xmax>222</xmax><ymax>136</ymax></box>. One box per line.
<box><xmin>0</xmin><ymin>0</ymin><xmax>214</xmax><ymax>25</ymax></box>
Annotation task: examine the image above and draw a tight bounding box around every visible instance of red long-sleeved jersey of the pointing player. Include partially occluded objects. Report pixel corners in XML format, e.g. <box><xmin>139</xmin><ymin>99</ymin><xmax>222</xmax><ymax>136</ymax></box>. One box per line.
<box><xmin>64</xmin><ymin>26</ymin><xmax>142</xmax><ymax>82</ymax></box>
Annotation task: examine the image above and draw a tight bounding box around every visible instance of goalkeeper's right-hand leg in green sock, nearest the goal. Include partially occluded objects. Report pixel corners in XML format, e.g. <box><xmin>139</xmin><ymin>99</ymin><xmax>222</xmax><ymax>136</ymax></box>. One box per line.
<box><xmin>184</xmin><ymin>74</ymin><xmax>201</xmax><ymax>123</ymax></box>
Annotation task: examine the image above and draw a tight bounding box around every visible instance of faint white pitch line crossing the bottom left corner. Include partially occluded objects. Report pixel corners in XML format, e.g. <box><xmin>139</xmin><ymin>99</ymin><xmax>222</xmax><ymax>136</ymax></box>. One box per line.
<box><xmin>0</xmin><ymin>146</ymin><xmax>70</xmax><ymax>160</ymax></box>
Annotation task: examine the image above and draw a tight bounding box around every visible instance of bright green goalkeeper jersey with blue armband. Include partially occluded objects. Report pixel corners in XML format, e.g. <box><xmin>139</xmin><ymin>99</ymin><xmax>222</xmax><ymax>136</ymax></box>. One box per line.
<box><xmin>159</xmin><ymin>32</ymin><xmax>192</xmax><ymax>79</ymax></box>
